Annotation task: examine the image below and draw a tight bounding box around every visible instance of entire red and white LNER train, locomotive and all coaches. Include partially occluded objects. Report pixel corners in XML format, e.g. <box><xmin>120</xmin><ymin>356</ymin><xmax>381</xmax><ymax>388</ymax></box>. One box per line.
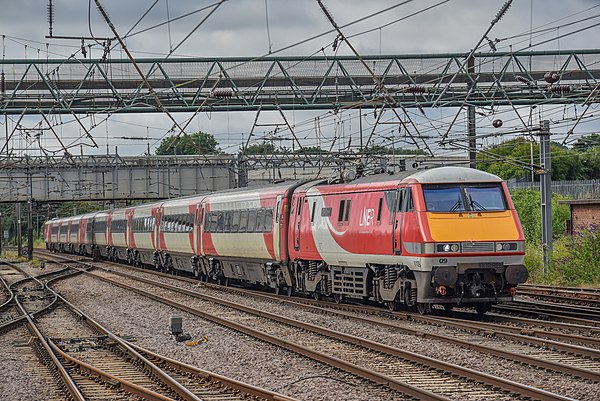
<box><xmin>44</xmin><ymin>167</ymin><xmax>528</xmax><ymax>313</ymax></box>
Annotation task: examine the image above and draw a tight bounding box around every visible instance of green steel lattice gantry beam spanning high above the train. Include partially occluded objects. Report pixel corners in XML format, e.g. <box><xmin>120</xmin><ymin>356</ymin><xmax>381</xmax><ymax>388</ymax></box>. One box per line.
<box><xmin>0</xmin><ymin>50</ymin><xmax>600</xmax><ymax>115</ymax></box>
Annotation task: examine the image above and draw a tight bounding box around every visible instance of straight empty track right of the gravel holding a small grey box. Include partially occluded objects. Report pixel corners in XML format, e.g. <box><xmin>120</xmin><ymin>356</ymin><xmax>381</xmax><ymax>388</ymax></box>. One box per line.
<box><xmin>38</xmin><ymin>252</ymin><xmax>582</xmax><ymax>399</ymax></box>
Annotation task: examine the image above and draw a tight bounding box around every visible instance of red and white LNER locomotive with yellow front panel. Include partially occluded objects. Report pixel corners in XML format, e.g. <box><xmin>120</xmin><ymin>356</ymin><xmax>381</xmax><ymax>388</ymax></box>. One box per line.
<box><xmin>288</xmin><ymin>167</ymin><xmax>527</xmax><ymax>311</ymax></box>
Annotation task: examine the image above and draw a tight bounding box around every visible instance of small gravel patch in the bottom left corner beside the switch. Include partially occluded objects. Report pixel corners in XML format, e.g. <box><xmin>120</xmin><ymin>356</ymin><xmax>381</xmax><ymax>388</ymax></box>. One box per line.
<box><xmin>0</xmin><ymin>327</ymin><xmax>64</xmax><ymax>401</ymax></box>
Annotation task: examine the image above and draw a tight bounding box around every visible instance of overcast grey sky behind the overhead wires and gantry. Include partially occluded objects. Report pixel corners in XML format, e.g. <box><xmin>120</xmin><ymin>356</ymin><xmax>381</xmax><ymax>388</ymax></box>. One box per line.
<box><xmin>0</xmin><ymin>0</ymin><xmax>600</xmax><ymax>155</ymax></box>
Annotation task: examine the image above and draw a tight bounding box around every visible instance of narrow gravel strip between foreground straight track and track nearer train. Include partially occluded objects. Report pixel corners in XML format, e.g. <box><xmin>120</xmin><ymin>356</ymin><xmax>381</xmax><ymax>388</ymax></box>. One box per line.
<box><xmin>101</xmin><ymin>267</ymin><xmax>600</xmax><ymax>400</ymax></box>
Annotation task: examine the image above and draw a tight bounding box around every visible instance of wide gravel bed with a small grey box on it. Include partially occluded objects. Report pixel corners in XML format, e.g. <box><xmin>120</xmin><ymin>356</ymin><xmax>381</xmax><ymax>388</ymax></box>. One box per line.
<box><xmin>54</xmin><ymin>276</ymin><xmax>412</xmax><ymax>401</ymax></box>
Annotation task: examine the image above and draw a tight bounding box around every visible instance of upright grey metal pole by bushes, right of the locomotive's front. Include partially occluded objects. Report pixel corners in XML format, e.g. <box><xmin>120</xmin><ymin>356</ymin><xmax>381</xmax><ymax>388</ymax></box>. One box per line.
<box><xmin>539</xmin><ymin>120</ymin><xmax>552</xmax><ymax>277</ymax></box>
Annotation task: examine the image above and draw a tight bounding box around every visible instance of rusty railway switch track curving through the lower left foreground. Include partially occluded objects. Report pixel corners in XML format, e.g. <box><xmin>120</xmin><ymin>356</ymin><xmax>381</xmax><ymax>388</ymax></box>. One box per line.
<box><xmin>1</xmin><ymin>256</ymin><xmax>291</xmax><ymax>401</ymax></box>
